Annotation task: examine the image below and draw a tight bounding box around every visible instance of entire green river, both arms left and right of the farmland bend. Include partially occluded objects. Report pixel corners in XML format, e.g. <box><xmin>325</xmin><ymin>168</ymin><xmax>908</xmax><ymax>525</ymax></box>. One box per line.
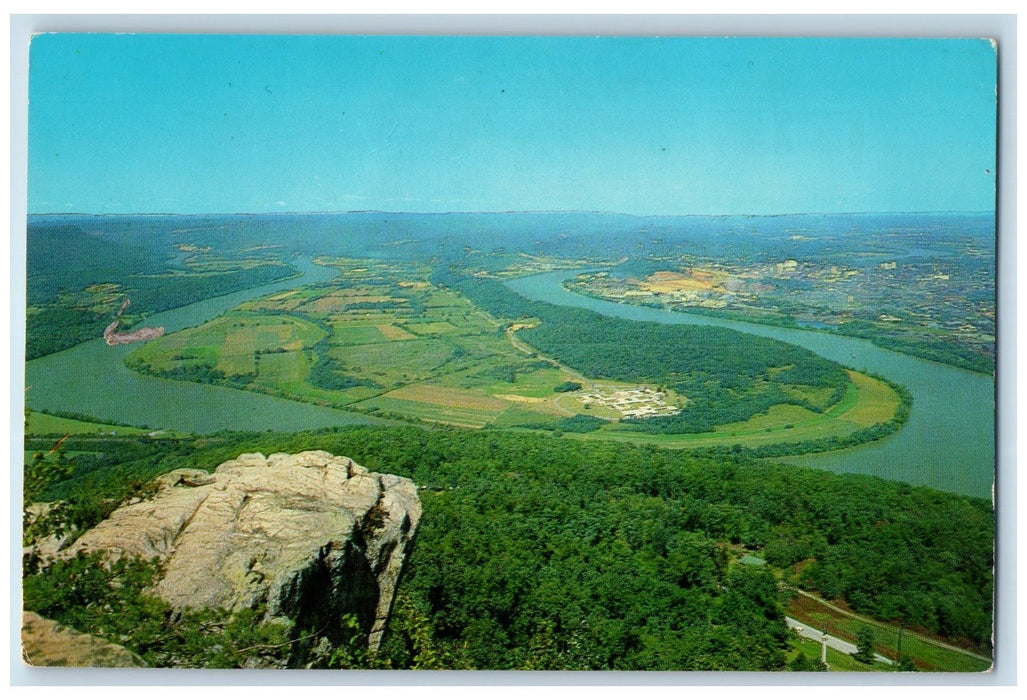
<box><xmin>26</xmin><ymin>258</ymin><xmax>995</xmax><ymax>498</ymax></box>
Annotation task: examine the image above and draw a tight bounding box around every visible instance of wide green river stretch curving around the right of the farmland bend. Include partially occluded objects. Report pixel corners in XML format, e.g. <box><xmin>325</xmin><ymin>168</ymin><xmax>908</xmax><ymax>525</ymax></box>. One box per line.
<box><xmin>506</xmin><ymin>270</ymin><xmax>995</xmax><ymax>499</ymax></box>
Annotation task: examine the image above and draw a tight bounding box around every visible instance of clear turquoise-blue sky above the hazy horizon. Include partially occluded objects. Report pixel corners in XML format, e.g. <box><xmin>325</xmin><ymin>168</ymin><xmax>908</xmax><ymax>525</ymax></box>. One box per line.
<box><xmin>29</xmin><ymin>34</ymin><xmax>996</xmax><ymax>215</ymax></box>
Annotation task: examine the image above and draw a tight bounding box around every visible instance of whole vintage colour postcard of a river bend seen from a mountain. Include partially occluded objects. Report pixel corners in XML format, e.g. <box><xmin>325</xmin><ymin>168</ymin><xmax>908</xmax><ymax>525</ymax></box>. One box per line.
<box><xmin>21</xmin><ymin>33</ymin><xmax>999</xmax><ymax>677</ymax></box>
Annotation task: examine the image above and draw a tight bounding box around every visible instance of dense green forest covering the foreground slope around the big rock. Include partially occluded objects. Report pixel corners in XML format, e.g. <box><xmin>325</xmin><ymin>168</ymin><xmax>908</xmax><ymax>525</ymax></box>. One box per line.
<box><xmin>26</xmin><ymin>427</ymin><xmax>994</xmax><ymax>670</ymax></box>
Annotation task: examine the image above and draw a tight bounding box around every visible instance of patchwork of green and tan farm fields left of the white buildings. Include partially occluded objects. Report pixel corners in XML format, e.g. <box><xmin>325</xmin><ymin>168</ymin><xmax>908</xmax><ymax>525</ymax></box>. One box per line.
<box><xmin>127</xmin><ymin>260</ymin><xmax>591</xmax><ymax>427</ymax></box>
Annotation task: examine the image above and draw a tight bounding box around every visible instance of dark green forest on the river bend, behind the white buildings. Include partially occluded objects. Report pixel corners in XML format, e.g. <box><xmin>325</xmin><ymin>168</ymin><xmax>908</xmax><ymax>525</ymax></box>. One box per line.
<box><xmin>432</xmin><ymin>269</ymin><xmax>848</xmax><ymax>433</ymax></box>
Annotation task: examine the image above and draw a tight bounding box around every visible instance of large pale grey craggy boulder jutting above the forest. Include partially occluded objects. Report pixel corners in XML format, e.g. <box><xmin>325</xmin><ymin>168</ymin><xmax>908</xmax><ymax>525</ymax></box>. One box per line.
<box><xmin>66</xmin><ymin>451</ymin><xmax>421</xmax><ymax>650</ymax></box>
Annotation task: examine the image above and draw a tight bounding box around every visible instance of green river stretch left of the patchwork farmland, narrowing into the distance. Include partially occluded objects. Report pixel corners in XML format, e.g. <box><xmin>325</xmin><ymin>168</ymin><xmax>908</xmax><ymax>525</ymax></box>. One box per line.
<box><xmin>25</xmin><ymin>258</ymin><xmax>385</xmax><ymax>433</ymax></box>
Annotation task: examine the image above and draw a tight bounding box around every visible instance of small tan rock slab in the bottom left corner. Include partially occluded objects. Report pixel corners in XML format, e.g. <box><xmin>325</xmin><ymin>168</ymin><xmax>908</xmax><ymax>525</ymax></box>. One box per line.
<box><xmin>22</xmin><ymin>612</ymin><xmax>145</xmax><ymax>668</ymax></box>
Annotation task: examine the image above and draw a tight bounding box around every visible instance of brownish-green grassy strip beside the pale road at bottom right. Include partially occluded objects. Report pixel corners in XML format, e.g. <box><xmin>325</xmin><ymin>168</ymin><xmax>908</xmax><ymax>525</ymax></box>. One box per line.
<box><xmin>786</xmin><ymin>595</ymin><xmax>991</xmax><ymax>672</ymax></box>
